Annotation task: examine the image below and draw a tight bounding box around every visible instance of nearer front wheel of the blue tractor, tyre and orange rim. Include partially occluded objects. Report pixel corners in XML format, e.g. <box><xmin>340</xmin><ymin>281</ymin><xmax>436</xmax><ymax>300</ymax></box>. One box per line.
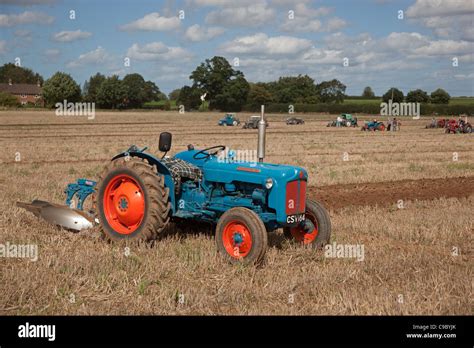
<box><xmin>216</xmin><ymin>207</ymin><xmax>268</xmax><ymax>264</ymax></box>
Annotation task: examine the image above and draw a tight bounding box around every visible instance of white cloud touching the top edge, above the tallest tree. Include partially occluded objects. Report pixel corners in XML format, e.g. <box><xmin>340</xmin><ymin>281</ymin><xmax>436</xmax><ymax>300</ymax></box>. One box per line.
<box><xmin>206</xmin><ymin>2</ymin><xmax>276</xmax><ymax>27</ymax></box>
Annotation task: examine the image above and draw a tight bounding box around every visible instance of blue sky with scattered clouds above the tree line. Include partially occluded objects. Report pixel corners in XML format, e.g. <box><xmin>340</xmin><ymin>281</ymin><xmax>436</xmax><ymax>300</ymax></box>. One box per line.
<box><xmin>0</xmin><ymin>0</ymin><xmax>474</xmax><ymax>96</ymax></box>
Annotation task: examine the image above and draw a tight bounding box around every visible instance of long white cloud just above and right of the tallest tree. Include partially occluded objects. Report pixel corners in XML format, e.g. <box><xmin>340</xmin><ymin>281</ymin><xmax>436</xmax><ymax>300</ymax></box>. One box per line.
<box><xmin>221</xmin><ymin>33</ymin><xmax>312</xmax><ymax>56</ymax></box>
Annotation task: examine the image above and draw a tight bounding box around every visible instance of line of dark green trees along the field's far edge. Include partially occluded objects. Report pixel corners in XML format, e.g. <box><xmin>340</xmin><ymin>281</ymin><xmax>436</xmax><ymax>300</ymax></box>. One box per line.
<box><xmin>0</xmin><ymin>56</ymin><xmax>450</xmax><ymax>111</ymax></box>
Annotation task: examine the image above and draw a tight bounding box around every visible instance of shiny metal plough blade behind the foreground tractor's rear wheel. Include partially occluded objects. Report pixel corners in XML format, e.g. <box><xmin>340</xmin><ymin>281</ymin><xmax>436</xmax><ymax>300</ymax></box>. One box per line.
<box><xmin>16</xmin><ymin>200</ymin><xmax>95</xmax><ymax>231</ymax></box>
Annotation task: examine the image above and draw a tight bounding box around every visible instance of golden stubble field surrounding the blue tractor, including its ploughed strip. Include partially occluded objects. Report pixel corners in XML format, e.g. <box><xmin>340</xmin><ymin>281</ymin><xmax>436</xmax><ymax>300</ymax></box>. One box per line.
<box><xmin>0</xmin><ymin>111</ymin><xmax>474</xmax><ymax>315</ymax></box>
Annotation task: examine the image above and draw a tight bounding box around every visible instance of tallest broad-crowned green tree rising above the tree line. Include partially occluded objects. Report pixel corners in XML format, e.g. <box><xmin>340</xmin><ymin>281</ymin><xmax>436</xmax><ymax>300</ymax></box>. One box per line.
<box><xmin>189</xmin><ymin>56</ymin><xmax>249</xmax><ymax>109</ymax></box>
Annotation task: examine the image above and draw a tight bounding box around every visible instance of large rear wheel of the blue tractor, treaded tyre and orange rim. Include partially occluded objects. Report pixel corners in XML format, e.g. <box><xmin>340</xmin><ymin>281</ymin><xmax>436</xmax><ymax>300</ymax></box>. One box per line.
<box><xmin>95</xmin><ymin>157</ymin><xmax>171</xmax><ymax>241</ymax></box>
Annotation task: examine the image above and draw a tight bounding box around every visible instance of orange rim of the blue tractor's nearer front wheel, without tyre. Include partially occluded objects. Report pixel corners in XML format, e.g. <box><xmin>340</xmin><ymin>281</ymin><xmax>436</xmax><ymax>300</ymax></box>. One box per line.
<box><xmin>222</xmin><ymin>220</ymin><xmax>252</xmax><ymax>259</ymax></box>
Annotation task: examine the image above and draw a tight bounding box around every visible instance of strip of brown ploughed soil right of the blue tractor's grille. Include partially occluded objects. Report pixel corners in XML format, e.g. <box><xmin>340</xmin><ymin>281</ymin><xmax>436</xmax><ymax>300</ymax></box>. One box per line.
<box><xmin>309</xmin><ymin>176</ymin><xmax>474</xmax><ymax>210</ymax></box>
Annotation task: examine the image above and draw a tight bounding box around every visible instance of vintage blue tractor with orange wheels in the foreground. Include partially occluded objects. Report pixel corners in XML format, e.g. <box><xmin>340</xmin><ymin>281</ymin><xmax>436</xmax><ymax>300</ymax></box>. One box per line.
<box><xmin>94</xmin><ymin>110</ymin><xmax>331</xmax><ymax>264</ymax></box>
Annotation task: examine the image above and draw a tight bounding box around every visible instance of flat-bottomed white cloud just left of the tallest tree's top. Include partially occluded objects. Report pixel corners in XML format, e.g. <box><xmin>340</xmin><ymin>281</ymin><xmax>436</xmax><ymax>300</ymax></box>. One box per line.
<box><xmin>127</xmin><ymin>42</ymin><xmax>193</xmax><ymax>61</ymax></box>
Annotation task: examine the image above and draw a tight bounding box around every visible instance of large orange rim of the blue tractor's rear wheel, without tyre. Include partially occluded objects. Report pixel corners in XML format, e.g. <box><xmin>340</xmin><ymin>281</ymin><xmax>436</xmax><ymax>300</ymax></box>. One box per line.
<box><xmin>103</xmin><ymin>174</ymin><xmax>145</xmax><ymax>234</ymax></box>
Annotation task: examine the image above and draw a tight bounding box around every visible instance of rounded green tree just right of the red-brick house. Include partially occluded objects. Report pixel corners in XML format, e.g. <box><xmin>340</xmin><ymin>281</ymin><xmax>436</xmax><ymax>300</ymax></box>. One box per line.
<box><xmin>43</xmin><ymin>72</ymin><xmax>81</xmax><ymax>107</ymax></box>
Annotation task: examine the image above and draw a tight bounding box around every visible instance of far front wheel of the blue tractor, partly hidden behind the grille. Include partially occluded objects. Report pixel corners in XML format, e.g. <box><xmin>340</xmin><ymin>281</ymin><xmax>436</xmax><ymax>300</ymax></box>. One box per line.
<box><xmin>283</xmin><ymin>199</ymin><xmax>331</xmax><ymax>248</ymax></box>
